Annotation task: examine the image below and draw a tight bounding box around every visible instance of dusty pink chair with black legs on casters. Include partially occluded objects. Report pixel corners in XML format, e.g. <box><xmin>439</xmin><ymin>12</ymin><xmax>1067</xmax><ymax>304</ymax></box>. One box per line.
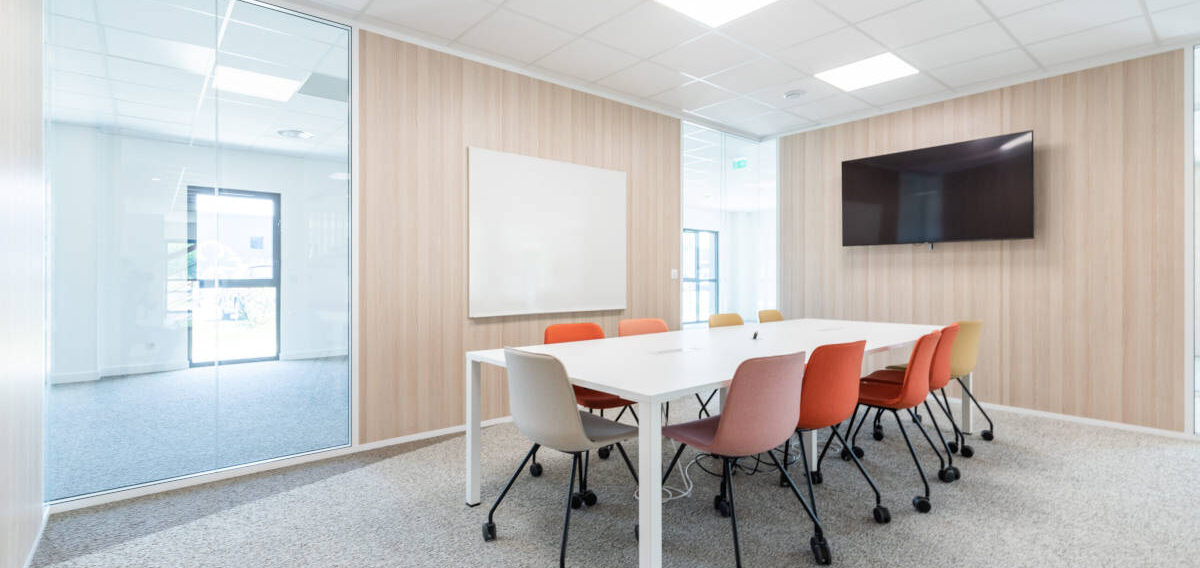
<box><xmin>662</xmin><ymin>352</ymin><xmax>830</xmax><ymax>567</ymax></box>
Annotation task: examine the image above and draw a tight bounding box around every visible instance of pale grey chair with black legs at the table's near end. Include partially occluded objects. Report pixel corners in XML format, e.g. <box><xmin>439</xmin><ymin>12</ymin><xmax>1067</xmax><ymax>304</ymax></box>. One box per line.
<box><xmin>484</xmin><ymin>348</ymin><xmax>637</xmax><ymax>568</ymax></box>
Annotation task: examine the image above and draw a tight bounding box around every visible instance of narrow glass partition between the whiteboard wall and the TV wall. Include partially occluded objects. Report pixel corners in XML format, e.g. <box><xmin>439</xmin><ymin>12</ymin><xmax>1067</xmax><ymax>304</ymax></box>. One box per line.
<box><xmin>679</xmin><ymin>122</ymin><xmax>786</xmax><ymax>327</ymax></box>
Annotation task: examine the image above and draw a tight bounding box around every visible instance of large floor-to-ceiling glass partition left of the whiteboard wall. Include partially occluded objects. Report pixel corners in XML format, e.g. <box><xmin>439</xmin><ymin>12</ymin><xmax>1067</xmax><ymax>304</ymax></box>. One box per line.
<box><xmin>46</xmin><ymin>0</ymin><xmax>350</xmax><ymax>501</ymax></box>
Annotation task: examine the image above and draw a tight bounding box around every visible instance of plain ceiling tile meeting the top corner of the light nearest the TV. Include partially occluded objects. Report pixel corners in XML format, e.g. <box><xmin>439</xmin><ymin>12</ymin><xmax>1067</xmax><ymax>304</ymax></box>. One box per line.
<box><xmin>858</xmin><ymin>0</ymin><xmax>990</xmax><ymax>49</ymax></box>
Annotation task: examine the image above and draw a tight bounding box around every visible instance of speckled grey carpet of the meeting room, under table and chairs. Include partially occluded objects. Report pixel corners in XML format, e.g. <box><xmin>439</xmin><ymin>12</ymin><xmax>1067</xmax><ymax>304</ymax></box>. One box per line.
<box><xmin>25</xmin><ymin>403</ymin><xmax>1200</xmax><ymax>568</ymax></box>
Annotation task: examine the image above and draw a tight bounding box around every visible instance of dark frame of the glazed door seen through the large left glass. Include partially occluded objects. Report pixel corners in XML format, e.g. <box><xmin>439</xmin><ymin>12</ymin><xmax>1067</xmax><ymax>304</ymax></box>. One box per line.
<box><xmin>187</xmin><ymin>185</ymin><xmax>283</xmax><ymax>367</ymax></box>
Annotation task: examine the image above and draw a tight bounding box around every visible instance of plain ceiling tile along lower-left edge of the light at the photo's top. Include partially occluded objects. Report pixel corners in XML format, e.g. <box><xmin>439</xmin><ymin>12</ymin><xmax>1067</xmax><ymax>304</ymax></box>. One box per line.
<box><xmin>588</xmin><ymin>2</ymin><xmax>708</xmax><ymax>58</ymax></box>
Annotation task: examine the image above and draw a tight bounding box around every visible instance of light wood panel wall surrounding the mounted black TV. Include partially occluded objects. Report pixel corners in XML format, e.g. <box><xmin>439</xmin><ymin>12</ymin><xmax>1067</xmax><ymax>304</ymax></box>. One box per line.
<box><xmin>780</xmin><ymin>52</ymin><xmax>1192</xmax><ymax>430</ymax></box>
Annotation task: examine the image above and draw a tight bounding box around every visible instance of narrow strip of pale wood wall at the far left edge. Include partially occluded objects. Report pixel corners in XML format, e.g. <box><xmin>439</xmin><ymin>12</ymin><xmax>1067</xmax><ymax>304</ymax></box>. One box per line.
<box><xmin>0</xmin><ymin>0</ymin><xmax>46</xmax><ymax>559</ymax></box>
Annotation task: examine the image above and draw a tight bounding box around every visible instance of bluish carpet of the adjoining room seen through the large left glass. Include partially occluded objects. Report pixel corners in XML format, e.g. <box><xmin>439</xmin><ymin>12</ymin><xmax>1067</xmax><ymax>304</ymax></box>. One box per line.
<box><xmin>46</xmin><ymin>357</ymin><xmax>350</xmax><ymax>501</ymax></box>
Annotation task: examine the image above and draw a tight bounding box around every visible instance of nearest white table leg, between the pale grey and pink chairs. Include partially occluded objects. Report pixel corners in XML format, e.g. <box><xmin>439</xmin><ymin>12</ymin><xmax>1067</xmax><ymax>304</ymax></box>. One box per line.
<box><xmin>637</xmin><ymin>402</ymin><xmax>662</xmax><ymax>568</ymax></box>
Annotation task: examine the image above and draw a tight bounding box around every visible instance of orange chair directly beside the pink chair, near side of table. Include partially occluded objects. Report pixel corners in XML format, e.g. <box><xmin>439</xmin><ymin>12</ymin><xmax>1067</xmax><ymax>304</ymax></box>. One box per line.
<box><xmin>779</xmin><ymin>341</ymin><xmax>892</xmax><ymax>524</ymax></box>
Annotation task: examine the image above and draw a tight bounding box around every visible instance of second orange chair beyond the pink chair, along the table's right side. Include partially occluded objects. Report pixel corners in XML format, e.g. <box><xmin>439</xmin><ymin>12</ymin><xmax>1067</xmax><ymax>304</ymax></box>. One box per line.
<box><xmin>840</xmin><ymin>330</ymin><xmax>942</xmax><ymax>513</ymax></box>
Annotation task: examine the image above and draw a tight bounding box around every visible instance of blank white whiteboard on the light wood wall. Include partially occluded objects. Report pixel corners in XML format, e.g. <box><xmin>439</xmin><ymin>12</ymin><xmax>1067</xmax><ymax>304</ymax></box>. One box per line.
<box><xmin>467</xmin><ymin>148</ymin><xmax>625</xmax><ymax>317</ymax></box>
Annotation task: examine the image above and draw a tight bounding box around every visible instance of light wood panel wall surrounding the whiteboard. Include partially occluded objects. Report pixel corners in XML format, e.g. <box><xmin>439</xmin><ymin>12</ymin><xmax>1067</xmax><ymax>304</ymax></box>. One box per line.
<box><xmin>359</xmin><ymin>32</ymin><xmax>680</xmax><ymax>442</ymax></box>
